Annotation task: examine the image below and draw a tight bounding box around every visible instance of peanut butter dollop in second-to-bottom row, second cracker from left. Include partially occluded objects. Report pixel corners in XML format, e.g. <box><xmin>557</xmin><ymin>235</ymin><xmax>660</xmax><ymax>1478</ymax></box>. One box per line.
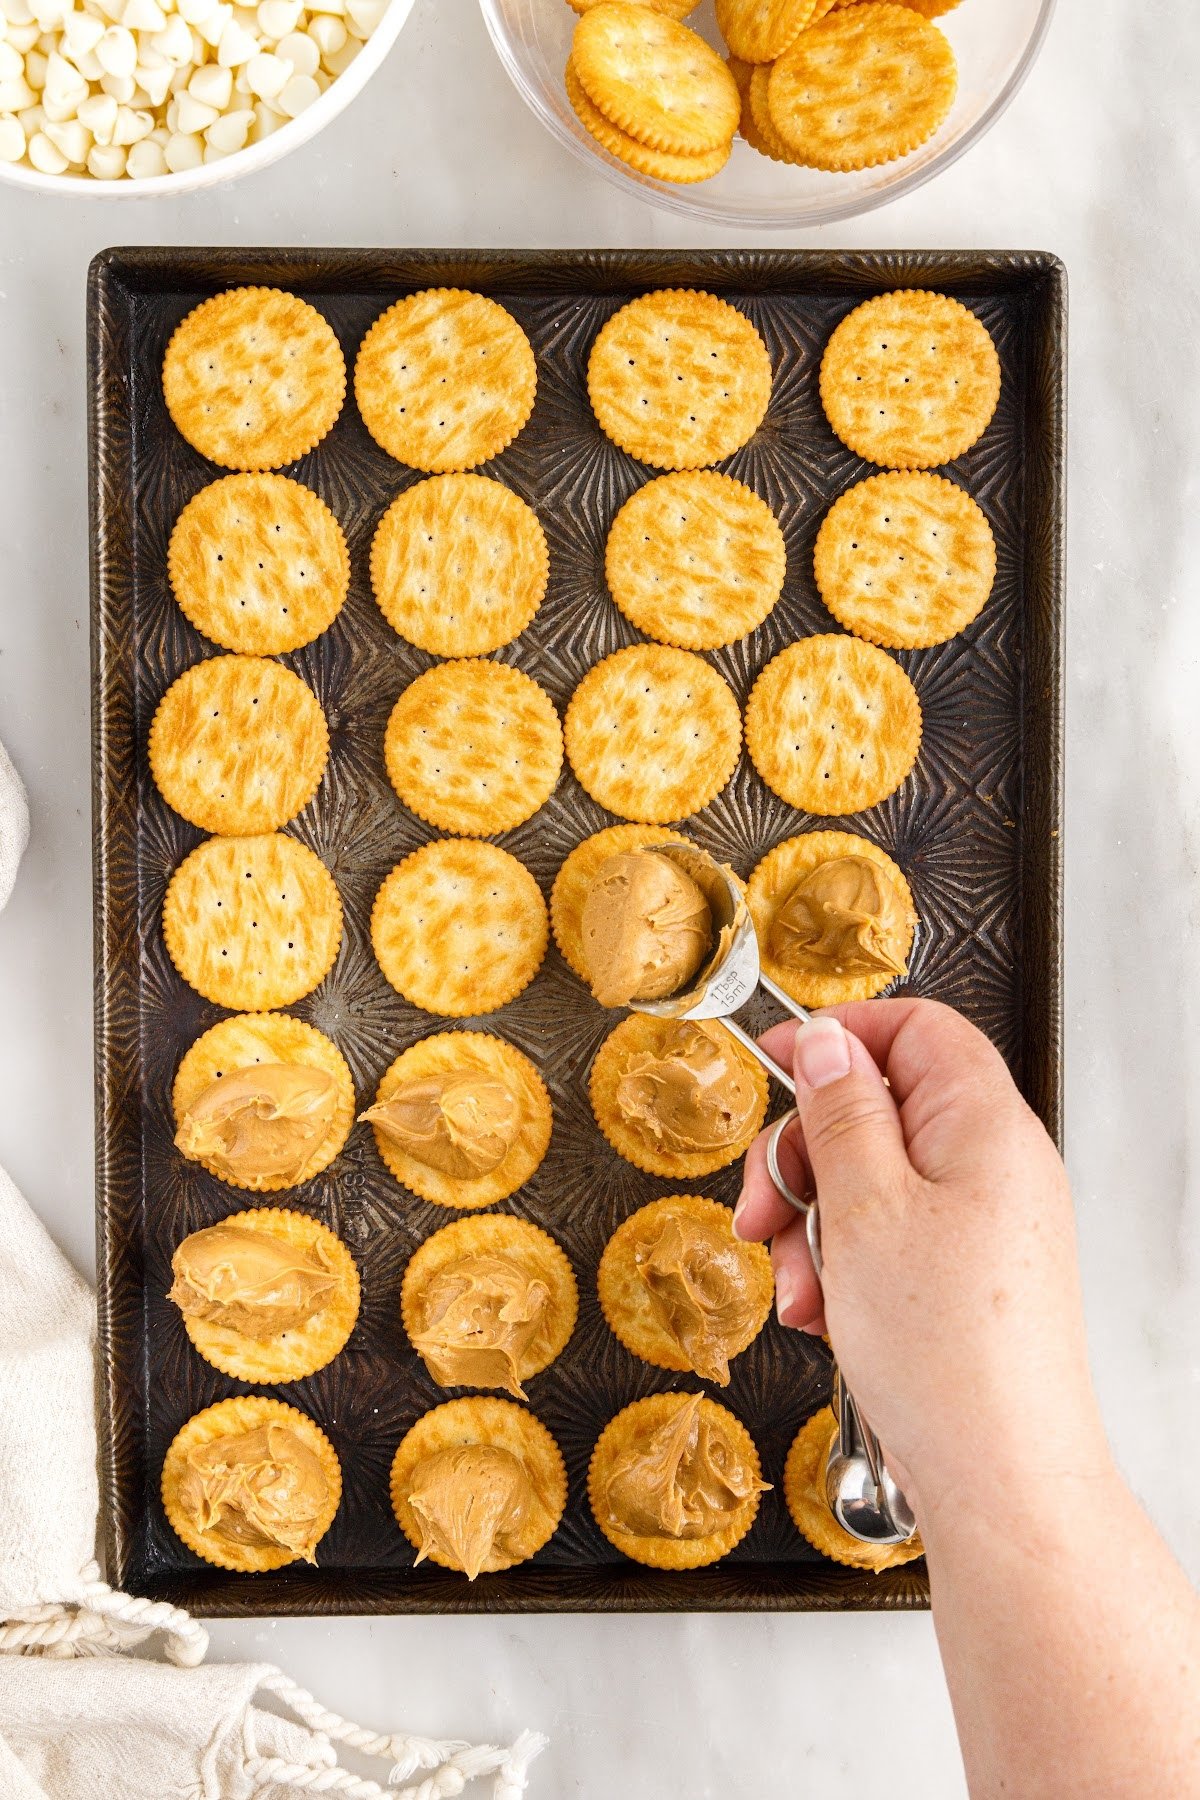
<box><xmin>412</xmin><ymin>1255</ymin><xmax>551</xmax><ymax>1400</ymax></box>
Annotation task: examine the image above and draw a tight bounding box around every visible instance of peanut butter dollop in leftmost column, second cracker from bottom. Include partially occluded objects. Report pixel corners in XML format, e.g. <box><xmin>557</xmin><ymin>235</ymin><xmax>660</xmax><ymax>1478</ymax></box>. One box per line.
<box><xmin>169</xmin><ymin>1224</ymin><xmax>338</xmax><ymax>1343</ymax></box>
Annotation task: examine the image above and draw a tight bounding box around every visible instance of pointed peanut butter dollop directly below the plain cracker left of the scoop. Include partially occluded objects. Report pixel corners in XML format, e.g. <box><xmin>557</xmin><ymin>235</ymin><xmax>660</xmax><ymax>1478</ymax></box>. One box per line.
<box><xmin>362</xmin><ymin>1071</ymin><xmax>520</xmax><ymax>1181</ymax></box>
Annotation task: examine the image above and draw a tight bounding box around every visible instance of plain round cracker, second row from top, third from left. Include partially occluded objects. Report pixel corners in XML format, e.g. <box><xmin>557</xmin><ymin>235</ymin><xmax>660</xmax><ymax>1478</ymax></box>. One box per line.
<box><xmin>604</xmin><ymin>470</ymin><xmax>788</xmax><ymax>650</ymax></box>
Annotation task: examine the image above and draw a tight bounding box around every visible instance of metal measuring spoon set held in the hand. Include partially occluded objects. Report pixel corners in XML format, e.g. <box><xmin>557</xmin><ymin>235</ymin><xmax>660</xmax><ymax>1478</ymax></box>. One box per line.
<box><xmin>630</xmin><ymin>844</ymin><xmax>916</xmax><ymax>1544</ymax></box>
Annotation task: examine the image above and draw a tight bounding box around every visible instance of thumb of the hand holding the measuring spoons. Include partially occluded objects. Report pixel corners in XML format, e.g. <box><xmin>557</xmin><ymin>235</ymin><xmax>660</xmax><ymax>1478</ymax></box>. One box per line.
<box><xmin>792</xmin><ymin>1013</ymin><xmax>909</xmax><ymax>1210</ymax></box>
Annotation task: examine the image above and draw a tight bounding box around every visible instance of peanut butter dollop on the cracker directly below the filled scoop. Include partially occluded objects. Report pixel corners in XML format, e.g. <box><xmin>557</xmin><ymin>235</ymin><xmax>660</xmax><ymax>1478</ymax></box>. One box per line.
<box><xmin>615</xmin><ymin>1019</ymin><xmax>757</xmax><ymax>1154</ymax></box>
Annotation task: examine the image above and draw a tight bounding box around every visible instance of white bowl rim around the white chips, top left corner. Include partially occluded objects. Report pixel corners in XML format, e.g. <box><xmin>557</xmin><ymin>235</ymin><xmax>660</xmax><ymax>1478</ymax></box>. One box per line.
<box><xmin>0</xmin><ymin>0</ymin><xmax>414</xmax><ymax>200</ymax></box>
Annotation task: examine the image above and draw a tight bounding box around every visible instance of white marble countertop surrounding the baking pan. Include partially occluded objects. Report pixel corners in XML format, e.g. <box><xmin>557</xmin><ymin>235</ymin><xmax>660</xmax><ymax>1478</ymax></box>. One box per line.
<box><xmin>0</xmin><ymin>0</ymin><xmax>1200</xmax><ymax>1800</ymax></box>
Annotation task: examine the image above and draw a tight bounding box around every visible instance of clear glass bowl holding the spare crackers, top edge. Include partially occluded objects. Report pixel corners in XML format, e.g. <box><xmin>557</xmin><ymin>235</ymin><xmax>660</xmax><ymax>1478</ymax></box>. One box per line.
<box><xmin>480</xmin><ymin>0</ymin><xmax>1054</xmax><ymax>230</ymax></box>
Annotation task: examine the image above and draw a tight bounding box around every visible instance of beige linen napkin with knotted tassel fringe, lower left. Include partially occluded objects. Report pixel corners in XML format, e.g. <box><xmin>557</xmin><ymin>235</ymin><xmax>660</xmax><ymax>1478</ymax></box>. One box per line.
<box><xmin>0</xmin><ymin>745</ymin><xmax>545</xmax><ymax>1800</ymax></box>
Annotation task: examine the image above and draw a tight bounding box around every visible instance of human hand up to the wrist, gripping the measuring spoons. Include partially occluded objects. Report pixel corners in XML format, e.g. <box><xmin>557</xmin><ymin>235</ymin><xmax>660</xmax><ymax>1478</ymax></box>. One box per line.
<box><xmin>734</xmin><ymin>999</ymin><xmax>1106</xmax><ymax>1528</ymax></box>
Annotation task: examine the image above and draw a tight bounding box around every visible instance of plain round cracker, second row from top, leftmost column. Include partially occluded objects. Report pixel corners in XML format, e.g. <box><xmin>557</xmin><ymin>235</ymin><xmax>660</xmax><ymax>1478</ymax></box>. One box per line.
<box><xmin>167</xmin><ymin>473</ymin><xmax>351</xmax><ymax>657</ymax></box>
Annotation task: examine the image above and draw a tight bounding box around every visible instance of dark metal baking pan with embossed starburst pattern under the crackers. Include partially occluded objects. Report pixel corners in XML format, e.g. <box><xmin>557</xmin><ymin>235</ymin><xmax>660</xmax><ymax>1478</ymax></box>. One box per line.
<box><xmin>88</xmin><ymin>250</ymin><xmax>1065</xmax><ymax>1615</ymax></box>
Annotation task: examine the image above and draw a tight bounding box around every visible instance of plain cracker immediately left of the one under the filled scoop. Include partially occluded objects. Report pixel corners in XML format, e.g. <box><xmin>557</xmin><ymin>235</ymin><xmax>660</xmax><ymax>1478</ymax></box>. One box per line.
<box><xmin>371</xmin><ymin>839</ymin><xmax>549</xmax><ymax>1019</ymax></box>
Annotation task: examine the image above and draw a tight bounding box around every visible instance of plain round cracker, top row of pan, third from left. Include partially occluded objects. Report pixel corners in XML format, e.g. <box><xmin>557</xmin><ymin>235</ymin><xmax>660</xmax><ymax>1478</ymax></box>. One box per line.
<box><xmin>588</xmin><ymin>289</ymin><xmax>772</xmax><ymax>468</ymax></box>
